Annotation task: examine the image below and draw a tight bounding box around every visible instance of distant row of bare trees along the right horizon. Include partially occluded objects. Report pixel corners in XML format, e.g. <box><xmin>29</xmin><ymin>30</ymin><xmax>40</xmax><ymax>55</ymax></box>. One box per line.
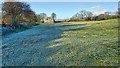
<box><xmin>69</xmin><ymin>10</ymin><xmax>119</xmax><ymax>21</ymax></box>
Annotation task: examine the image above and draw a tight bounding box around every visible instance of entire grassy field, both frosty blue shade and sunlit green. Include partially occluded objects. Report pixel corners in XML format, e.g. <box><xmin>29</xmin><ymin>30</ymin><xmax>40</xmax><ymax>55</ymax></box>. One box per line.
<box><xmin>2</xmin><ymin>19</ymin><xmax>120</xmax><ymax>66</ymax></box>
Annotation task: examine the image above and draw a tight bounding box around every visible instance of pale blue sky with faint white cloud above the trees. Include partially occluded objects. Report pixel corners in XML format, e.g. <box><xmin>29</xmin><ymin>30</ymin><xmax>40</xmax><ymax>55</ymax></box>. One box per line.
<box><xmin>29</xmin><ymin>2</ymin><xmax>118</xmax><ymax>19</ymax></box>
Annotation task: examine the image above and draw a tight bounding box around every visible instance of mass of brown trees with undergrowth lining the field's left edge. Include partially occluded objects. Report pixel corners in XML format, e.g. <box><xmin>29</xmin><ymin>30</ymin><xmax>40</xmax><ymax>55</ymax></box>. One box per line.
<box><xmin>2</xmin><ymin>2</ymin><xmax>40</xmax><ymax>28</ymax></box>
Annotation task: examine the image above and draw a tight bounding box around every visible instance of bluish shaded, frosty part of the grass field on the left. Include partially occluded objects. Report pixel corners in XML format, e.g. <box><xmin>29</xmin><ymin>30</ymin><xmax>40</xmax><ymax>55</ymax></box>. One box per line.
<box><xmin>2</xmin><ymin>24</ymin><xmax>84</xmax><ymax>66</ymax></box>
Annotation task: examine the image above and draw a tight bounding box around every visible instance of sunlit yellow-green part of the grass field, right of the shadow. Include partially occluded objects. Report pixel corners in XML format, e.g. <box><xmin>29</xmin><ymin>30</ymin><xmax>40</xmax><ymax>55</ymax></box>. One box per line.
<box><xmin>48</xmin><ymin>19</ymin><xmax>120</xmax><ymax>66</ymax></box>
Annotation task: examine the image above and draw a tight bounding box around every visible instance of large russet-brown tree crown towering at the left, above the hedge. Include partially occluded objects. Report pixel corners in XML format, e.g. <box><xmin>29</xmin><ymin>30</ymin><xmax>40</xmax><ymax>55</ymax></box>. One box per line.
<box><xmin>2</xmin><ymin>2</ymin><xmax>37</xmax><ymax>27</ymax></box>
